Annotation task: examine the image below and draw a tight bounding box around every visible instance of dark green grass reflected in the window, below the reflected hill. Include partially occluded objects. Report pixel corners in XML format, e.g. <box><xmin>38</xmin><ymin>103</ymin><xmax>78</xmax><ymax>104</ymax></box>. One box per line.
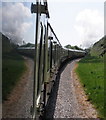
<box><xmin>2</xmin><ymin>52</ymin><xmax>25</xmax><ymax>101</ymax></box>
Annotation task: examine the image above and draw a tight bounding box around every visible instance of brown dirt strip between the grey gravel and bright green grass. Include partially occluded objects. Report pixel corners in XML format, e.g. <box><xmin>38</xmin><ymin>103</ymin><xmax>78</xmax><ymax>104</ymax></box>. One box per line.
<box><xmin>71</xmin><ymin>60</ymin><xmax>98</xmax><ymax>118</ymax></box>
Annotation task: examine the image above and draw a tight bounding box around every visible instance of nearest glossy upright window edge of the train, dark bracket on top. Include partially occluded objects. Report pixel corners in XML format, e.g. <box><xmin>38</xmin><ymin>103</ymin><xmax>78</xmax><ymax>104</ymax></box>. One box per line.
<box><xmin>31</xmin><ymin>0</ymin><xmax>49</xmax><ymax>119</ymax></box>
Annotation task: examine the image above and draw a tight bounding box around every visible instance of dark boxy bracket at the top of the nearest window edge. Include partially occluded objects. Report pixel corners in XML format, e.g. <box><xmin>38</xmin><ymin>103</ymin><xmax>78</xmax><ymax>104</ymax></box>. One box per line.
<box><xmin>31</xmin><ymin>3</ymin><xmax>48</xmax><ymax>15</ymax></box>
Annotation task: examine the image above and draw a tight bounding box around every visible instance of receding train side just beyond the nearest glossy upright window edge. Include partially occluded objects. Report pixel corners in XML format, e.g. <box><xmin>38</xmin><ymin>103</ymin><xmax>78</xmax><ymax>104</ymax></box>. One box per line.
<box><xmin>45</xmin><ymin>23</ymin><xmax>61</xmax><ymax>104</ymax></box>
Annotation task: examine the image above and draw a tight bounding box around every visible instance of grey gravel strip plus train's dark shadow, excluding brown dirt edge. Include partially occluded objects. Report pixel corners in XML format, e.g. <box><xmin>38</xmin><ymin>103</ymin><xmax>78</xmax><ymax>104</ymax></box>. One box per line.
<box><xmin>46</xmin><ymin>61</ymin><xmax>81</xmax><ymax>118</ymax></box>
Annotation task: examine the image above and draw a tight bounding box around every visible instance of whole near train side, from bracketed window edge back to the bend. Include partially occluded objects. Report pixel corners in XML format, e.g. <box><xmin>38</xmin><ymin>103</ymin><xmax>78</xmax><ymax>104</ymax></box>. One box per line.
<box><xmin>32</xmin><ymin>0</ymin><xmax>68</xmax><ymax>118</ymax></box>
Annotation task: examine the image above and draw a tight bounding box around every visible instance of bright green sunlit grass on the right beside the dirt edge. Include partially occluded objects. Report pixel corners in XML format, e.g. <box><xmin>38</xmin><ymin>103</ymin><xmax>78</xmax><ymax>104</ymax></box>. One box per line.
<box><xmin>76</xmin><ymin>56</ymin><xmax>104</xmax><ymax>118</ymax></box>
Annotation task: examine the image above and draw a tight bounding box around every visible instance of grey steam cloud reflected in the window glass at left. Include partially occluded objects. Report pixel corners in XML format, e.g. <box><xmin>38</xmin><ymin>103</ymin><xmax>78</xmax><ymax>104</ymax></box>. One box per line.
<box><xmin>2</xmin><ymin>2</ymin><xmax>32</xmax><ymax>43</ymax></box>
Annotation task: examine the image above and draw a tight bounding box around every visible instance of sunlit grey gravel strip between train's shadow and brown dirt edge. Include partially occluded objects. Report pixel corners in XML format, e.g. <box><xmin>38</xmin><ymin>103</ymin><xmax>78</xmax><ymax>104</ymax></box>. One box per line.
<box><xmin>54</xmin><ymin>59</ymin><xmax>79</xmax><ymax>118</ymax></box>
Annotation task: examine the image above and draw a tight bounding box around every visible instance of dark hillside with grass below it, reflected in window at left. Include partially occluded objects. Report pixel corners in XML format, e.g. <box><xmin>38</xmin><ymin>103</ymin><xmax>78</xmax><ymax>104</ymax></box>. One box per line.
<box><xmin>0</xmin><ymin>33</ymin><xmax>26</xmax><ymax>102</ymax></box>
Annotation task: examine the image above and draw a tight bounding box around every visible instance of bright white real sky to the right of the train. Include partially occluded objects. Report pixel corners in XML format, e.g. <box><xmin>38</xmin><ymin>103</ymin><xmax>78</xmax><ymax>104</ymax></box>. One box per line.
<box><xmin>49</xmin><ymin>0</ymin><xmax>104</xmax><ymax>47</ymax></box>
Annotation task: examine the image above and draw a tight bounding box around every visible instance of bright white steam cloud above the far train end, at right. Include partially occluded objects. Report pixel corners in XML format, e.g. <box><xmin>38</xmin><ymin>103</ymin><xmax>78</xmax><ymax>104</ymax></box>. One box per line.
<box><xmin>75</xmin><ymin>9</ymin><xmax>104</xmax><ymax>48</ymax></box>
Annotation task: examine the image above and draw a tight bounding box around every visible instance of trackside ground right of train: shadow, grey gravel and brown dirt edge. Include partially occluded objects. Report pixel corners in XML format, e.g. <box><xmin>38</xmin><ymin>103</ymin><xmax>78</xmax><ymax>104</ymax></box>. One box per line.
<box><xmin>46</xmin><ymin>60</ymin><xmax>97</xmax><ymax>118</ymax></box>
